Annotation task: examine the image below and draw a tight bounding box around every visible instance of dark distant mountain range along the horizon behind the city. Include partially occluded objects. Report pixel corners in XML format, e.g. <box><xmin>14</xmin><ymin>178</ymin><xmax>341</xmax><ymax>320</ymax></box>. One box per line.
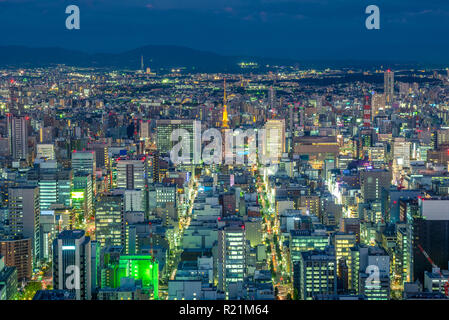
<box><xmin>0</xmin><ymin>45</ymin><xmax>424</xmax><ymax>73</ymax></box>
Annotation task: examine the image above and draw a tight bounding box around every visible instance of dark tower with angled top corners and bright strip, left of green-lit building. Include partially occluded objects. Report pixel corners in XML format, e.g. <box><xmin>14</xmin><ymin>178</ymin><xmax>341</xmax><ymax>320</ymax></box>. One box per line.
<box><xmin>53</xmin><ymin>230</ymin><xmax>92</xmax><ymax>300</ymax></box>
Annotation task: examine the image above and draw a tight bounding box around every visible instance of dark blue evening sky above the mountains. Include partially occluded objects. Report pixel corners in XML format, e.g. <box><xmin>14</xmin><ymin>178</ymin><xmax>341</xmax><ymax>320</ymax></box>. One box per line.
<box><xmin>0</xmin><ymin>0</ymin><xmax>449</xmax><ymax>63</ymax></box>
